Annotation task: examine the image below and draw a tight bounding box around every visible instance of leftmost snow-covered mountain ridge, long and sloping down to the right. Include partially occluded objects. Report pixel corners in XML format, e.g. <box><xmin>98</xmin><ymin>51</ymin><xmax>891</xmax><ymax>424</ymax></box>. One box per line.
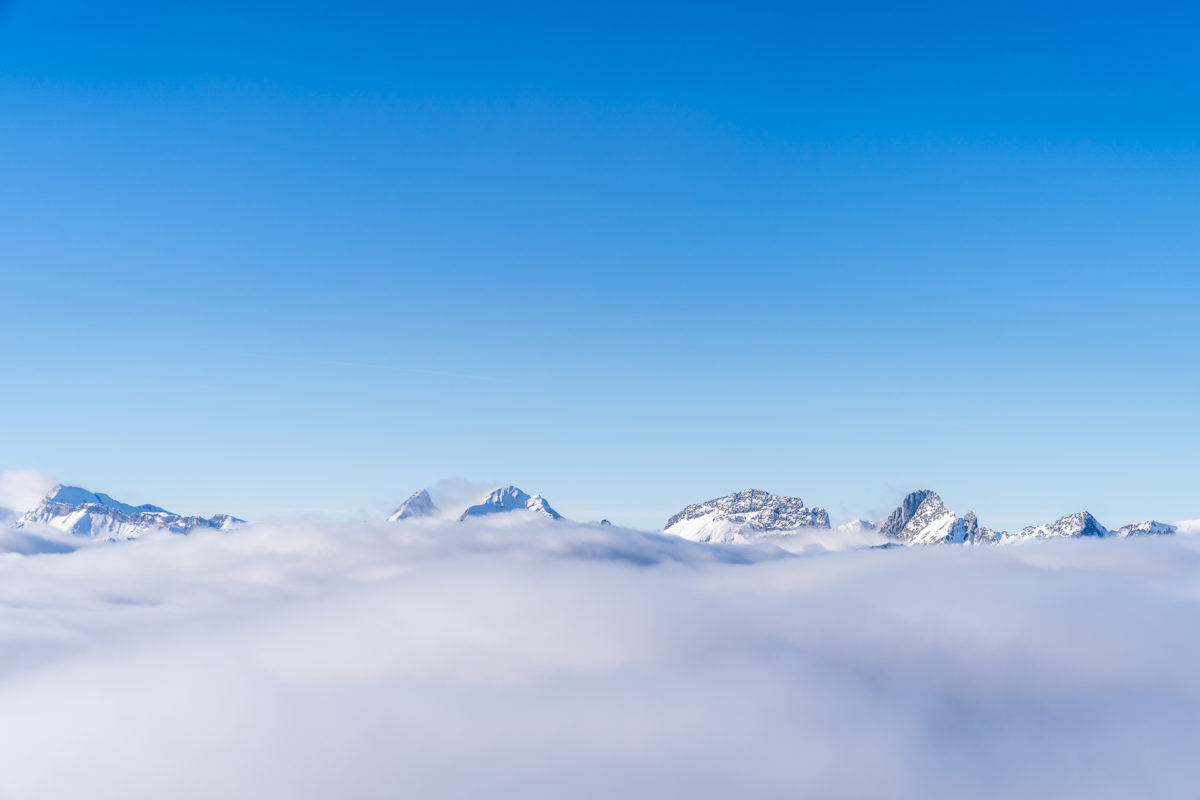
<box><xmin>12</xmin><ymin>485</ymin><xmax>245</xmax><ymax>540</ymax></box>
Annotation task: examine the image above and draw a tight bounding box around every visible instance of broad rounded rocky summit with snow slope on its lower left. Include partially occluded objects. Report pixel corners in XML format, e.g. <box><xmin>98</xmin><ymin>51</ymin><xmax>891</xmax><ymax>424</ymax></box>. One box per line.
<box><xmin>662</xmin><ymin>489</ymin><xmax>829</xmax><ymax>545</ymax></box>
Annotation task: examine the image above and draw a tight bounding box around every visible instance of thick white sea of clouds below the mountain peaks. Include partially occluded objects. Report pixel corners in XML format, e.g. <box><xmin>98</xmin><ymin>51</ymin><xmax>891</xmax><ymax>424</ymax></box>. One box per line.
<box><xmin>0</xmin><ymin>512</ymin><xmax>1200</xmax><ymax>800</ymax></box>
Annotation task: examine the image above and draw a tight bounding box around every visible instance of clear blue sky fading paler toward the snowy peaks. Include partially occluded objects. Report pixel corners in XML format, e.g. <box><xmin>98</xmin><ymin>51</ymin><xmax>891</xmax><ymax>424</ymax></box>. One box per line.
<box><xmin>0</xmin><ymin>0</ymin><xmax>1200</xmax><ymax>528</ymax></box>
